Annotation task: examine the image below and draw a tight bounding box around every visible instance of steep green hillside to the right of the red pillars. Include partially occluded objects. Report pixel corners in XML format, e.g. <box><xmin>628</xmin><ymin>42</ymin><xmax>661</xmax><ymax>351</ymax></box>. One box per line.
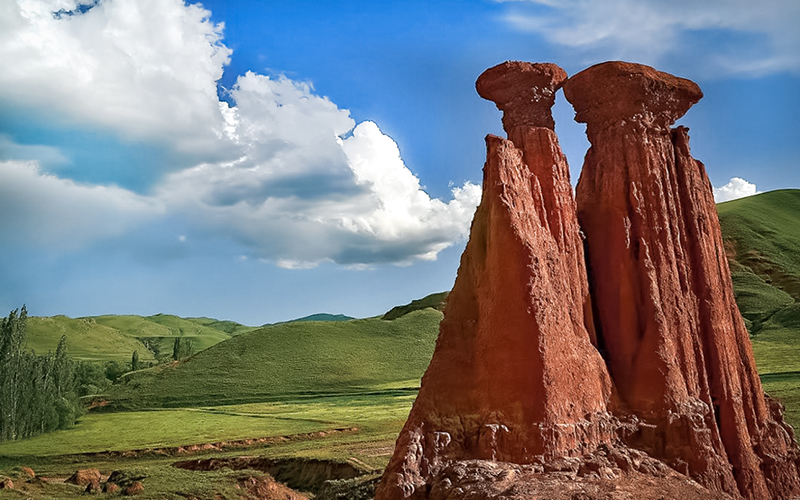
<box><xmin>717</xmin><ymin>190</ymin><xmax>800</xmax><ymax>428</ymax></box>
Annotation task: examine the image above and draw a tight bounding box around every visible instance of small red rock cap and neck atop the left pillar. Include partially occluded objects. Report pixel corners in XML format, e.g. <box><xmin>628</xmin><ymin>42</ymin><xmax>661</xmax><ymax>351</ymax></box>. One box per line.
<box><xmin>475</xmin><ymin>61</ymin><xmax>567</xmax><ymax>134</ymax></box>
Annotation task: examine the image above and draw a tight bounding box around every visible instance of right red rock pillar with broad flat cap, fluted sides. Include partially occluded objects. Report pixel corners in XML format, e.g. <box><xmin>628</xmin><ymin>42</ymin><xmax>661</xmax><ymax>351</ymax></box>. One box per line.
<box><xmin>564</xmin><ymin>62</ymin><xmax>800</xmax><ymax>499</ymax></box>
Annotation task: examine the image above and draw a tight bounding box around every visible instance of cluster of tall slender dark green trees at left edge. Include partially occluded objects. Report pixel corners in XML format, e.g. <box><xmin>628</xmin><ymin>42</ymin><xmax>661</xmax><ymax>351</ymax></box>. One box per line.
<box><xmin>0</xmin><ymin>306</ymin><xmax>81</xmax><ymax>441</ymax></box>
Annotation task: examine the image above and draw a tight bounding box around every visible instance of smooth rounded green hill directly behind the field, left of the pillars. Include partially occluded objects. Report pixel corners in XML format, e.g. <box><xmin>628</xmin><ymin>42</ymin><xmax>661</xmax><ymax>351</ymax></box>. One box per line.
<box><xmin>98</xmin><ymin>308</ymin><xmax>442</xmax><ymax>408</ymax></box>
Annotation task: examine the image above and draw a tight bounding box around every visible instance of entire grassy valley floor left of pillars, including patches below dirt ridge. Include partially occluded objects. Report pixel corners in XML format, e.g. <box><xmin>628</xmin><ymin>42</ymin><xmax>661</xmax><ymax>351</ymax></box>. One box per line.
<box><xmin>0</xmin><ymin>390</ymin><xmax>416</xmax><ymax>500</ymax></box>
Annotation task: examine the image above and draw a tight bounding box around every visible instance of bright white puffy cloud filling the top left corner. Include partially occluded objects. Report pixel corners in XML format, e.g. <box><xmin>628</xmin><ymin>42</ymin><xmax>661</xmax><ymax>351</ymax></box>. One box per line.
<box><xmin>0</xmin><ymin>0</ymin><xmax>231</xmax><ymax>151</ymax></box>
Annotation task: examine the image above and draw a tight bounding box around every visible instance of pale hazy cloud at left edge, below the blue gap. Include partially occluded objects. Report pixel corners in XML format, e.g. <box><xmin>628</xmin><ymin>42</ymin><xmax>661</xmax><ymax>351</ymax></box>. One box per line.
<box><xmin>0</xmin><ymin>161</ymin><xmax>164</xmax><ymax>251</ymax></box>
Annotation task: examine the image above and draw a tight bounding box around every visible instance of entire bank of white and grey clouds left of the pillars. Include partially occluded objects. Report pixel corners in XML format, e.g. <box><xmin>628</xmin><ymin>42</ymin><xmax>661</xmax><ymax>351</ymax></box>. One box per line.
<box><xmin>0</xmin><ymin>0</ymin><xmax>480</xmax><ymax>268</ymax></box>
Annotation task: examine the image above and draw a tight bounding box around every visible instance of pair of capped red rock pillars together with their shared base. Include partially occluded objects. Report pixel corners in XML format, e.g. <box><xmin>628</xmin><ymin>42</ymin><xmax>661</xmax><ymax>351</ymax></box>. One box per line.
<box><xmin>376</xmin><ymin>62</ymin><xmax>800</xmax><ymax>500</ymax></box>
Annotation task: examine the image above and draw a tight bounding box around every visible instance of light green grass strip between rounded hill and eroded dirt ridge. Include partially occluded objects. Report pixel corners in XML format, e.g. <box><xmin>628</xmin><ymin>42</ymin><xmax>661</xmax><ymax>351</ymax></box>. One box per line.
<box><xmin>0</xmin><ymin>390</ymin><xmax>416</xmax><ymax>461</ymax></box>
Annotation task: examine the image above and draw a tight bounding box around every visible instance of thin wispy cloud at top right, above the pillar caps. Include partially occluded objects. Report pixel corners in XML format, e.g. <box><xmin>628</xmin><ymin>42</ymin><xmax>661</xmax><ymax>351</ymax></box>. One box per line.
<box><xmin>500</xmin><ymin>0</ymin><xmax>800</xmax><ymax>75</ymax></box>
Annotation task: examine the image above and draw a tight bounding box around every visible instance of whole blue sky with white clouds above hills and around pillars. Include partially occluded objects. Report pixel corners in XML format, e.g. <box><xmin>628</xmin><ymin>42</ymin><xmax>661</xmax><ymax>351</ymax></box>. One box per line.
<box><xmin>0</xmin><ymin>0</ymin><xmax>800</xmax><ymax>325</ymax></box>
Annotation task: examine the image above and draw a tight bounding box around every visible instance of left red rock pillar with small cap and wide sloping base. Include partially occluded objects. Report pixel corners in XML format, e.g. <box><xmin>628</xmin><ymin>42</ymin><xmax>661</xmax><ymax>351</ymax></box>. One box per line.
<box><xmin>376</xmin><ymin>63</ymin><xmax>616</xmax><ymax>500</ymax></box>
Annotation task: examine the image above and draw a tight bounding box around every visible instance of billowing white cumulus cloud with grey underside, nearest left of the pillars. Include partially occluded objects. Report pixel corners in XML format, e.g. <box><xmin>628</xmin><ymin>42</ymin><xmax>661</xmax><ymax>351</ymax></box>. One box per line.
<box><xmin>157</xmin><ymin>73</ymin><xmax>480</xmax><ymax>268</ymax></box>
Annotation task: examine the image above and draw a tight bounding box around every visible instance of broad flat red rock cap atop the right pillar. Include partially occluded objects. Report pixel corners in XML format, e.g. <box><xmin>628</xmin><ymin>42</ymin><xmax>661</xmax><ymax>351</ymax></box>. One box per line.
<box><xmin>564</xmin><ymin>61</ymin><xmax>703</xmax><ymax>131</ymax></box>
